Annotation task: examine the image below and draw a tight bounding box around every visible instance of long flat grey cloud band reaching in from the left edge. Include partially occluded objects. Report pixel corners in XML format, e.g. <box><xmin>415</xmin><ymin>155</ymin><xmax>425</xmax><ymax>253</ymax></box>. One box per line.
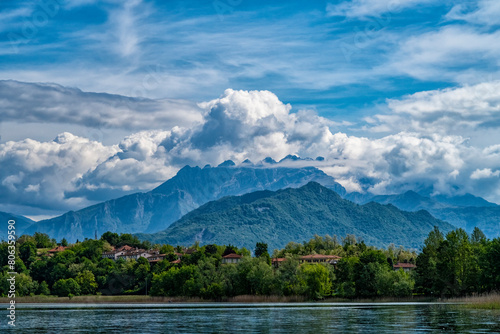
<box><xmin>0</xmin><ymin>80</ymin><xmax>202</xmax><ymax>130</ymax></box>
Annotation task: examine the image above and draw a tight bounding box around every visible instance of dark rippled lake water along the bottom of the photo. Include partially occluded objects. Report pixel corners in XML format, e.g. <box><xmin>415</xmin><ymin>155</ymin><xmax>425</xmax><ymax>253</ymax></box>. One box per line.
<box><xmin>0</xmin><ymin>303</ymin><xmax>500</xmax><ymax>334</ymax></box>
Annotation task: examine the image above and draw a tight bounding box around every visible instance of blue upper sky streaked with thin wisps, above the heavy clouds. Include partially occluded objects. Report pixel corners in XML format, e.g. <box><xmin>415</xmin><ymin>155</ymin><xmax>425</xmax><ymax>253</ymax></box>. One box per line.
<box><xmin>0</xmin><ymin>0</ymin><xmax>482</xmax><ymax>120</ymax></box>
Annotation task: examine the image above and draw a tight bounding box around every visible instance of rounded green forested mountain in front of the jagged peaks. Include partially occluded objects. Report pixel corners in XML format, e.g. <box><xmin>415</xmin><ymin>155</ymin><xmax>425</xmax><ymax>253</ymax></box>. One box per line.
<box><xmin>138</xmin><ymin>182</ymin><xmax>454</xmax><ymax>249</ymax></box>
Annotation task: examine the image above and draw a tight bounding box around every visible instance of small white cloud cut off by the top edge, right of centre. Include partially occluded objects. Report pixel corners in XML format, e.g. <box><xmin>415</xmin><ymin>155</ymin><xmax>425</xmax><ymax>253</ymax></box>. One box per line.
<box><xmin>326</xmin><ymin>0</ymin><xmax>432</xmax><ymax>18</ymax></box>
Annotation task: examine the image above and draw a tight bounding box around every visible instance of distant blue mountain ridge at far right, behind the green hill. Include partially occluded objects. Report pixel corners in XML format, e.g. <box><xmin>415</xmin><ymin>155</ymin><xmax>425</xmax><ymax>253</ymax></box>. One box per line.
<box><xmin>347</xmin><ymin>191</ymin><xmax>500</xmax><ymax>238</ymax></box>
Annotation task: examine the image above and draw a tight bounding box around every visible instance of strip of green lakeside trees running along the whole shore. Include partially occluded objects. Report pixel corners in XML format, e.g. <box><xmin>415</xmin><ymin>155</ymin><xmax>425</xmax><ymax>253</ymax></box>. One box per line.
<box><xmin>0</xmin><ymin>228</ymin><xmax>500</xmax><ymax>300</ymax></box>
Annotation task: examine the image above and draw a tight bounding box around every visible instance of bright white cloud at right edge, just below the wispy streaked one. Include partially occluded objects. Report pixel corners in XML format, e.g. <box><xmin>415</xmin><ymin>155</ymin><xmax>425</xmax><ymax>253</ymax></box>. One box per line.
<box><xmin>366</xmin><ymin>81</ymin><xmax>500</xmax><ymax>145</ymax></box>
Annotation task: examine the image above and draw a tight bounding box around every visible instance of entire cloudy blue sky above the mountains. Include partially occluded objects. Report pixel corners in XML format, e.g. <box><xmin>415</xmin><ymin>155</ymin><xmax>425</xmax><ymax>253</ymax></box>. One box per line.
<box><xmin>0</xmin><ymin>0</ymin><xmax>500</xmax><ymax>219</ymax></box>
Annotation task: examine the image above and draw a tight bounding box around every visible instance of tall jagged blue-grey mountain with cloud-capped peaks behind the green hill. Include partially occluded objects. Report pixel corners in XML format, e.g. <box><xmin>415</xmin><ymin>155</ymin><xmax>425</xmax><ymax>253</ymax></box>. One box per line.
<box><xmin>26</xmin><ymin>159</ymin><xmax>345</xmax><ymax>242</ymax></box>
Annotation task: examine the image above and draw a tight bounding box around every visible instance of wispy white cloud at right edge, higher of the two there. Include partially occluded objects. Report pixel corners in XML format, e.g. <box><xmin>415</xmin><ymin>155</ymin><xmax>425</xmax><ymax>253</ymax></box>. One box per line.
<box><xmin>386</xmin><ymin>25</ymin><xmax>500</xmax><ymax>83</ymax></box>
